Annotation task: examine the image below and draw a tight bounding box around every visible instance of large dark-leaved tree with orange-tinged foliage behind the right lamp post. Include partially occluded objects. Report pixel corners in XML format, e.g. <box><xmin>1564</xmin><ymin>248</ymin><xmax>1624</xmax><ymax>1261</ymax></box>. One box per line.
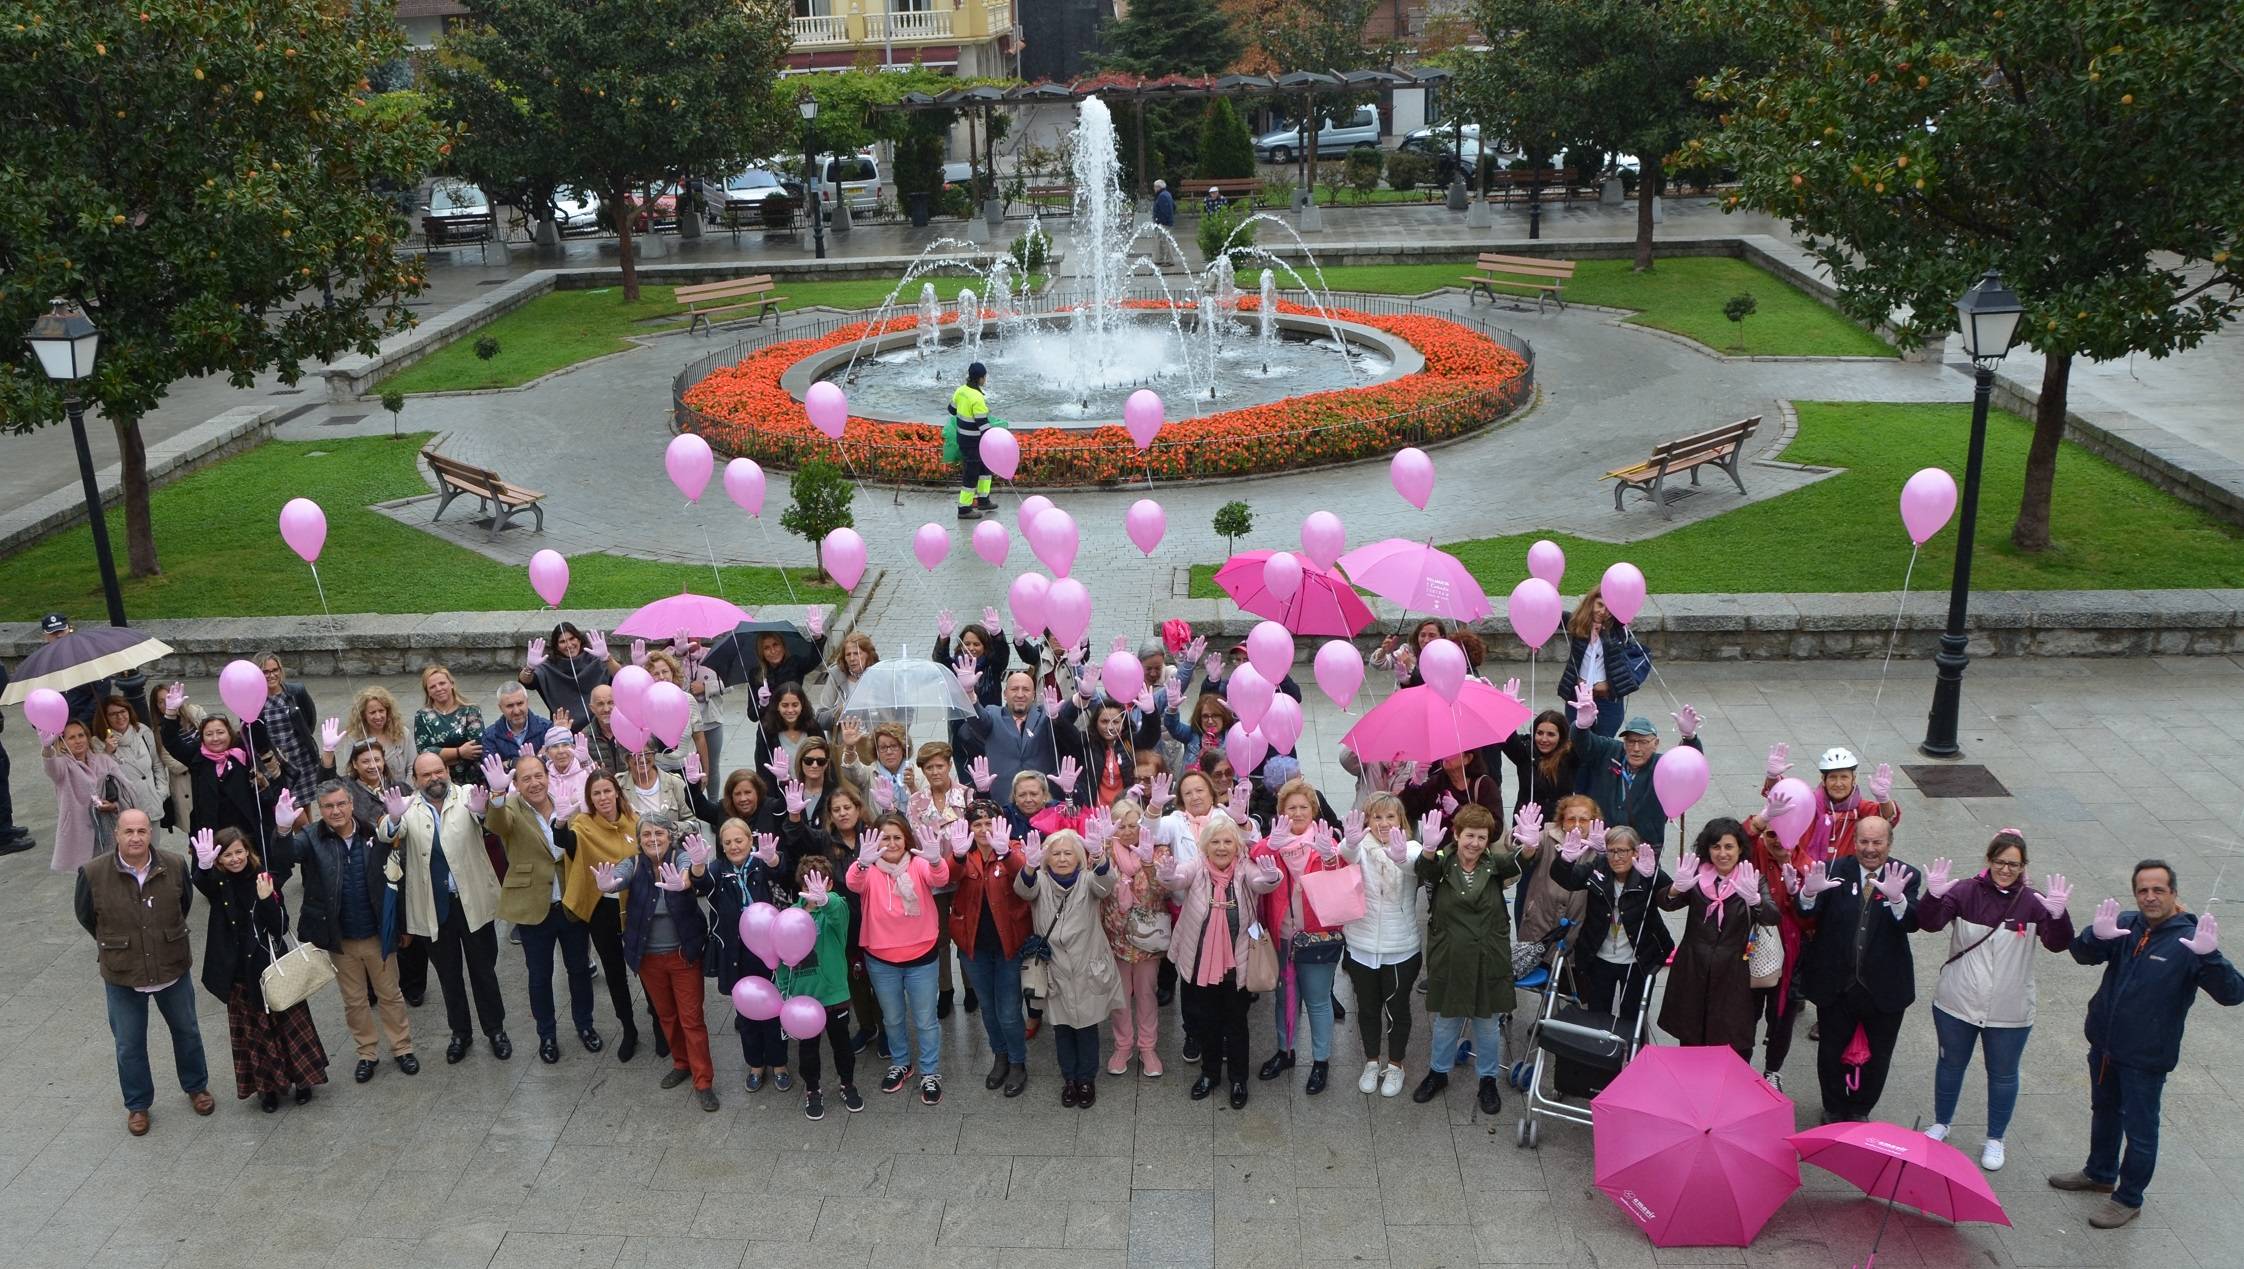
<box><xmin>1705</xmin><ymin>0</ymin><xmax>2244</xmax><ymax>552</ymax></box>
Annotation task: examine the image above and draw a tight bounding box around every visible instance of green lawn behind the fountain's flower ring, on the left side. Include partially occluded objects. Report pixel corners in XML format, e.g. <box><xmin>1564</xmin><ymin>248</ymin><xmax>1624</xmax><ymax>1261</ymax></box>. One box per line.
<box><xmin>375</xmin><ymin>278</ymin><xmax>1027</xmax><ymax>395</ymax></box>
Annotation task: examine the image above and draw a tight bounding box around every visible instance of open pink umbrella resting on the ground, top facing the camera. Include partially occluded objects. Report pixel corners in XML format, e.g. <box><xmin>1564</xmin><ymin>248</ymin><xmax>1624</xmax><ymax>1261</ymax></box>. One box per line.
<box><xmin>1589</xmin><ymin>1045</ymin><xmax>1800</xmax><ymax>1247</ymax></box>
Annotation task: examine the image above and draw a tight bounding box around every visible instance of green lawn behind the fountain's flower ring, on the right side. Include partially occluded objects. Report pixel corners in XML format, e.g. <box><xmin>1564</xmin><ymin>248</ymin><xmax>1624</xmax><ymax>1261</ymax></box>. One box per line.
<box><xmin>1279</xmin><ymin>256</ymin><xmax>1894</xmax><ymax>356</ymax></box>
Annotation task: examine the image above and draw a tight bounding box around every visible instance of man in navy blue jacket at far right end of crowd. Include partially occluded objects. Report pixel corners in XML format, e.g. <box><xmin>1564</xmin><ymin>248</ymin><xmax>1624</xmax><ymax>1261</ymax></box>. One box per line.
<box><xmin>2049</xmin><ymin>859</ymin><xmax>2244</xmax><ymax>1229</ymax></box>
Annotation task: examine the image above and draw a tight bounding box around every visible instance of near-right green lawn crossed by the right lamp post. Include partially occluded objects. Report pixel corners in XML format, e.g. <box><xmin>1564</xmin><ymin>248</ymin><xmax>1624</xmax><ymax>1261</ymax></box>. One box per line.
<box><xmin>1192</xmin><ymin>401</ymin><xmax>2244</xmax><ymax>612</ymax></box>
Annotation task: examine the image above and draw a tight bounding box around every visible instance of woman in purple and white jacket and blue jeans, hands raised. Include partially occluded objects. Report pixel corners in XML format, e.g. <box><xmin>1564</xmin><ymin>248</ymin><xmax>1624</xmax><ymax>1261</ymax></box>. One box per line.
<box><xmin>1916</xmin><ymin>827</ymin><xmax>2073</xmax><ymax>1173</ymax></box>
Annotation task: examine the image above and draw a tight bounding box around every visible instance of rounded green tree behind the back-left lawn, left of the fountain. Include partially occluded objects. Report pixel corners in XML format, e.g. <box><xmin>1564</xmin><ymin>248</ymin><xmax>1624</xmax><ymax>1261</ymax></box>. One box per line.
<box><xmin>431</xmin><ymin>0</ymin><xmax>797</xmax><ymax>303</ymax></box>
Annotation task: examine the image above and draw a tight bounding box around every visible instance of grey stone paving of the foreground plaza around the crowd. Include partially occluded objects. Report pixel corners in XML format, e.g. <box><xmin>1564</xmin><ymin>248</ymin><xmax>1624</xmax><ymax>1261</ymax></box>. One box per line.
<box><xmin>0</xmin><ymin>654</ymin><xmax>2244</xmax><ymax>1269</ymax></box>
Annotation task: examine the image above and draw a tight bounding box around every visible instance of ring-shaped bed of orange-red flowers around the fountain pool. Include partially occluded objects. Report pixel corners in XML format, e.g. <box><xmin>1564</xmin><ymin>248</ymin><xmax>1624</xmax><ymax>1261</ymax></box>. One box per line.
<box><xmin>680</xmin><ymin>296</ymin><xmax>1533</xmax><ymax>484</ymax></box>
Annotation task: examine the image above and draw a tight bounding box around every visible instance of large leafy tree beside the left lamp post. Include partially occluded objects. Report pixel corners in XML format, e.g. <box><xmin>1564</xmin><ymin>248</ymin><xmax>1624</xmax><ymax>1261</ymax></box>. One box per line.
<box><xmin>0</xmin><ymin>0</ymin><xmax>444</xmax><ymax>576</ymax></box>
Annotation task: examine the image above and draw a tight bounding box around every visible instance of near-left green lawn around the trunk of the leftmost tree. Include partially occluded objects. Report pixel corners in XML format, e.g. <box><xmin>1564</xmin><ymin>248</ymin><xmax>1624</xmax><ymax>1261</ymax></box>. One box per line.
<box><xmin>0</xmin><ymin>433</ymin><xmax>842</xmax><ymax>617</ymax></box>
